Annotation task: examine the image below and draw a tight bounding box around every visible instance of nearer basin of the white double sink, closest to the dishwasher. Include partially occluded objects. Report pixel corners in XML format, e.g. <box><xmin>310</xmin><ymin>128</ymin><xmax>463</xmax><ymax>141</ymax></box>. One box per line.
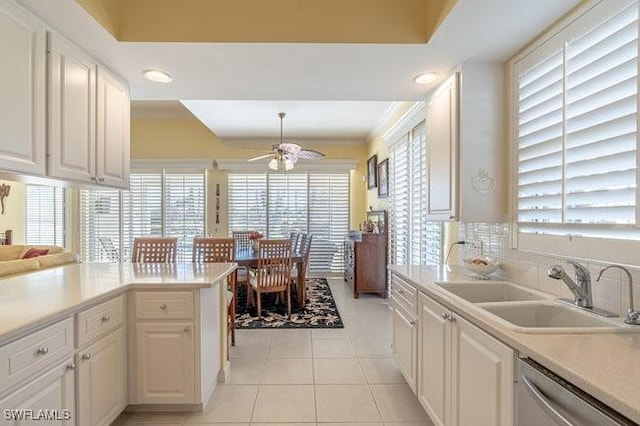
<box><xmin>482</xmin><ymin>303</ymin><xmax>632</xmax><ymax>333</ymax></box>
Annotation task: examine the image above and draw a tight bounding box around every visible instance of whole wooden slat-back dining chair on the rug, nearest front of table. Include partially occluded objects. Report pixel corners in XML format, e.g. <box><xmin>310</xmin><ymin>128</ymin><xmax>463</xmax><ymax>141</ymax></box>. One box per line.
<box><xmin>249</xmin><ymin>240</ymin><xmax>291</xmax><ymax>318</ymax></box>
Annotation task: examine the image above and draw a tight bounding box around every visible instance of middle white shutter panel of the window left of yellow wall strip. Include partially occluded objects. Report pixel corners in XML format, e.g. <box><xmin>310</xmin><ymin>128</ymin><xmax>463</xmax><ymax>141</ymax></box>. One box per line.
<box><xmin>122</xmin><ymin>172</ymin><xmax>162</xmax><ymax>261</ymax></box>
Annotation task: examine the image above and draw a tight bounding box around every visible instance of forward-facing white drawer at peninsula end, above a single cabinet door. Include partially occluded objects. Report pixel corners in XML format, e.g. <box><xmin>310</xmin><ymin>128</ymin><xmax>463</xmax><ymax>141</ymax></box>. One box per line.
<box><xmin>136</xmin><ymin>291</ymin><xmax>193</xmax><ymax>319</ymax></box>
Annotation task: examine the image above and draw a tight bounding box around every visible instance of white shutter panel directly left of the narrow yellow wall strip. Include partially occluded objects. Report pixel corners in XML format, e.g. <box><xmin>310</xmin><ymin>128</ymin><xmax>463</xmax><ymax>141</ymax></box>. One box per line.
<box><xmin>164</xmin><ymin>171</ymin><xmax>205</xmax><ymax>262</ymax></box>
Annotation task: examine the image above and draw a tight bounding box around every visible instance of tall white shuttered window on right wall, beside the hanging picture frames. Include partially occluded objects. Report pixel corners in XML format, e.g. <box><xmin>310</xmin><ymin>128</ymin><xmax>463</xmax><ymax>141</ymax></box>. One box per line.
<box><xmin>389</xmin><ymin>121</ymin><xmax>441</xmax><ymax>265</ymax></box>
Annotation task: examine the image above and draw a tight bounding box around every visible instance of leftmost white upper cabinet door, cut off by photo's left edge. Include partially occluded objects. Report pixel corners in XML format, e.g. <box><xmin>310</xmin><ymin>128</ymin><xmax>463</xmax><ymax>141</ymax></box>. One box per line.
<box><xmin>0</xmin><ymin>0</ymin><xmax>46</xmax><ymax>175</ymax></box>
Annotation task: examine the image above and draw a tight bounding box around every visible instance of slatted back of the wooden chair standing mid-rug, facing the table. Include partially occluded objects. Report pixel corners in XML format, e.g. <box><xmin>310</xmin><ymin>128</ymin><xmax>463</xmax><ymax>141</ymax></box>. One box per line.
<box><xmin>256</xmin><ymin>240</ymin><xmax>291</xmax><ymax>292</ymax></box>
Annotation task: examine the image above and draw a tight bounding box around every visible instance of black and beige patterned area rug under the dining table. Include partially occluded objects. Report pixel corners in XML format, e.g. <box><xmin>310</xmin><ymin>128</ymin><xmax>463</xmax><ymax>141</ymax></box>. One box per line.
<box><xmin>236</xmin><ymin>278</ymin><xmax>344</xmax><ymax>329</ymax></box>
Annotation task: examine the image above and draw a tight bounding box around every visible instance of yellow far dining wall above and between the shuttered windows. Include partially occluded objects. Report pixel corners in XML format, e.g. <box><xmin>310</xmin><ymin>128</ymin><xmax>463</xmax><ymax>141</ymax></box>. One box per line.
<box><xmin>131</xmin><ymin>119</ymin><xmax>366</xmax><ymax>235</ymax></box>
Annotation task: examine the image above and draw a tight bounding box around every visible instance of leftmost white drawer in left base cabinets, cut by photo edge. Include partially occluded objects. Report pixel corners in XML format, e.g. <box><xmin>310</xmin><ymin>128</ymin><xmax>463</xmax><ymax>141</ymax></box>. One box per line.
<box><xmin>0</xmin><ymin>318</ymin><xmax>73</xmax><ymax>393</ymax></box>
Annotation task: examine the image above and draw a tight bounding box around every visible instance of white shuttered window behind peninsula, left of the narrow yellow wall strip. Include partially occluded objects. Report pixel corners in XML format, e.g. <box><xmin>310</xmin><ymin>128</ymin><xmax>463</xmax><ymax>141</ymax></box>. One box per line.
<box><xmin>80</xmin><ymin>171</ymin><xmax>205</xmax><ymax>262</ymax></box>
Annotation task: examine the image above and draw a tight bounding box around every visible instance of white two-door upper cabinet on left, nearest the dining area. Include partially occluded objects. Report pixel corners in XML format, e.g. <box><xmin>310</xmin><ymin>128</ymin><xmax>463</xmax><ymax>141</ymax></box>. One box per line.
<box><xmin>48</xmin><ymin>33</ymin><xmax>130</xmax><ymax>188</ymax></box>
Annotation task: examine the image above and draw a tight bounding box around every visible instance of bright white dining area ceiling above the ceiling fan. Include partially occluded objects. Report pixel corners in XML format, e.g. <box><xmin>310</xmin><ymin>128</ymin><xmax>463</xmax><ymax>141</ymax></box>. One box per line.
<box><xmin>182</xmin><ymin>100</ymin><xmax>394</xmax><ymax>139</ymax></box>
